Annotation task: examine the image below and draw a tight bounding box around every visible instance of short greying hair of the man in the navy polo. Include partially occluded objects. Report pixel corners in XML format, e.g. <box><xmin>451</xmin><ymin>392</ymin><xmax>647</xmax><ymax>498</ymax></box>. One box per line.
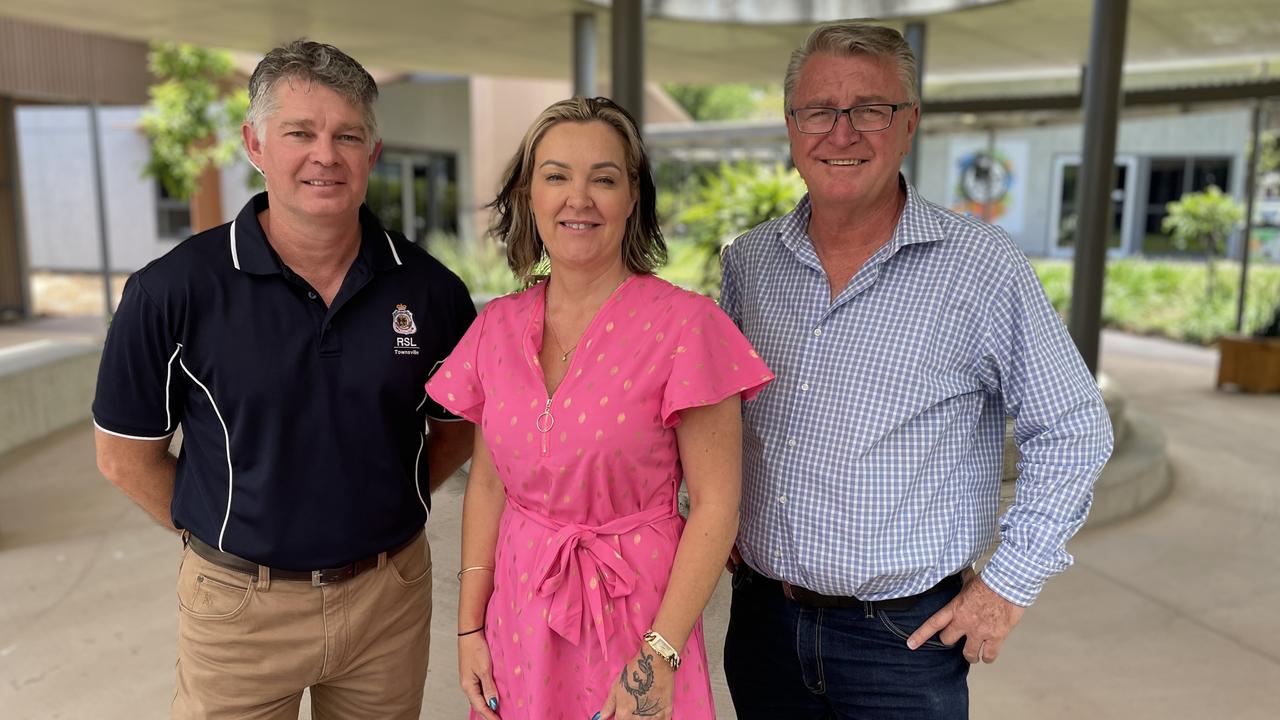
<box><xmin>244</xmin><ymin>38</ymin><xmax>379</xmax><ymax>147</ymax></box>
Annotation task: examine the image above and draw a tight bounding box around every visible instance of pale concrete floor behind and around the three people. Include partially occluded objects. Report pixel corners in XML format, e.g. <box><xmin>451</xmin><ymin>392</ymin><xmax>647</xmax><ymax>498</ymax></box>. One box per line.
<box><xmin>0</xmin><ymin>333</ymin><xmax>1280</xmax><ymax>720</ymax></box>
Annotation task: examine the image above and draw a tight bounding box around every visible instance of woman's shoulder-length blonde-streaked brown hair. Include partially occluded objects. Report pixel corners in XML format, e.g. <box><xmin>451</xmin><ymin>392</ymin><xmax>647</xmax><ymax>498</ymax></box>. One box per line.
<box><xmin>488</xmin><ymin>97</ymin><xmax>667</xmax><ymax>283</ymax></box>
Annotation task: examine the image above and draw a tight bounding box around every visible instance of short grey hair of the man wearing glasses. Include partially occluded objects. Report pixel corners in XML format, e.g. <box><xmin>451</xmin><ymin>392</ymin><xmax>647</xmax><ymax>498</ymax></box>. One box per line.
<box><xmin>782</xmin><ymin>23</ymin><xmax>920</xmax><ymax>111</ymax></box>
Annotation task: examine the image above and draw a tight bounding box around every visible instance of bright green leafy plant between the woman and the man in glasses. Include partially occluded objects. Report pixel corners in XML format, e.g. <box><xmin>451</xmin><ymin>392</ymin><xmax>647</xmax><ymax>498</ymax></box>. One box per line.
<box><xmin>678</xmin><ymin>163</ymin><xmax>805</xmax><ymax>296</ymax></box>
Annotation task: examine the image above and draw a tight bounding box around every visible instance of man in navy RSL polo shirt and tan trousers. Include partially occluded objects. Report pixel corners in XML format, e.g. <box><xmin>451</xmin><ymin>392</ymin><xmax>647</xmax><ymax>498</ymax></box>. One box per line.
<box><xmin>93</xmin><ymin>41</ymin><xmax>475</xmax><ymax>717</ymax></box>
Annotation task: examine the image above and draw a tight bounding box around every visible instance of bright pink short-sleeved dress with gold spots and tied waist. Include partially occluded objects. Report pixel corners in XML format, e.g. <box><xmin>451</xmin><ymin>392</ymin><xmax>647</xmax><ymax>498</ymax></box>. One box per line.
<box><xmin>426</xmin><ymin>275</ymin><xmax>773</xmax><ymax>720</ymax></box>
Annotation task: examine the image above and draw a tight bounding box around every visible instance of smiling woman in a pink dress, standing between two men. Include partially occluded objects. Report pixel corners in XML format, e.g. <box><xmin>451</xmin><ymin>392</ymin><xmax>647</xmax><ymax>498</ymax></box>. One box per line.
<box><xmin>428</xmin><ymin>97</ymin><xmax>773</xmax><ymax>720</ymax></box>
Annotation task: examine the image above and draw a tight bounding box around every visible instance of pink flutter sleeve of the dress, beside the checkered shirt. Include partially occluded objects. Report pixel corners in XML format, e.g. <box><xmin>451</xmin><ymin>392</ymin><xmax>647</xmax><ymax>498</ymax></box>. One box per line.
<box><xmin>662</xmin><ymin>295</ymin><xmax>773</xmax><ymax>428</ymax></box>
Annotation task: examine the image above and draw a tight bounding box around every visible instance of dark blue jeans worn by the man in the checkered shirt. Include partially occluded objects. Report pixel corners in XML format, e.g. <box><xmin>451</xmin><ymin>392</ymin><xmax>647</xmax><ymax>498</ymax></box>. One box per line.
<box><xmin>724</xmin><ymin>564</ymin><xmax>969</xmax><ymax>720</ymax></box>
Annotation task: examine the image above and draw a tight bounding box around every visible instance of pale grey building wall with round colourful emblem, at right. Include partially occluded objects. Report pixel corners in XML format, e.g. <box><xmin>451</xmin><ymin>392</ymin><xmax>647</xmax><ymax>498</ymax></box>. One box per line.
<box><xmin>916</xmin><ymin>108</ymin><xmax>1249</xmax><ymax>256</ymax></box>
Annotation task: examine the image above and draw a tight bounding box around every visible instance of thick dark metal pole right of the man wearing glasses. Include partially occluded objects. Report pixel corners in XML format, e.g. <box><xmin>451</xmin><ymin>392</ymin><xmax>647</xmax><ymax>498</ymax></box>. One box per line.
<box><xmin>1068</xmin><ymin>0</ymin><xmax>1129</xmax><ymax>374</ymax></box>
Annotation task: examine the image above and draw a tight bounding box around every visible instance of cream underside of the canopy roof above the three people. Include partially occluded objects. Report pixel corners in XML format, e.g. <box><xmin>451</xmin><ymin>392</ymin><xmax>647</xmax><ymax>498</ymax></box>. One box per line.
<box><xmin>0</xmin><ymin>0</ymin><xmax>1280</xmax><ymax>87</ymax></box>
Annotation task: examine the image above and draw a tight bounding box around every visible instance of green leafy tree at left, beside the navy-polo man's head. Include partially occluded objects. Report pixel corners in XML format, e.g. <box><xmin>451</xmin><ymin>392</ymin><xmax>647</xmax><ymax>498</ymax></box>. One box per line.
<box><xmin>142</xmin><ymin>42</ymin><xmax>248</xmax><ymax>200</ymax></box>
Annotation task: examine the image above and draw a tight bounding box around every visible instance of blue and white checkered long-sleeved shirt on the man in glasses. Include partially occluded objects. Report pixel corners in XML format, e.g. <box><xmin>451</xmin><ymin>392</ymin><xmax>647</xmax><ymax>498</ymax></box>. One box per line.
<box><xmin>721</xmin><ymin>181</ymin><xmax>1112</xmax><ymax>606</ymax></box>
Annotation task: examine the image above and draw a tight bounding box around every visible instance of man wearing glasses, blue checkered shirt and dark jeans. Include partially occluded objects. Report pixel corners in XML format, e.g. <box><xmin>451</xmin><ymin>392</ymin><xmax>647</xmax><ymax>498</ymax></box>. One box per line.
<box><xmin>722</xmin><ymin>24</ymin><xmax>1112</xmax><ymax>720</ymax></box>
